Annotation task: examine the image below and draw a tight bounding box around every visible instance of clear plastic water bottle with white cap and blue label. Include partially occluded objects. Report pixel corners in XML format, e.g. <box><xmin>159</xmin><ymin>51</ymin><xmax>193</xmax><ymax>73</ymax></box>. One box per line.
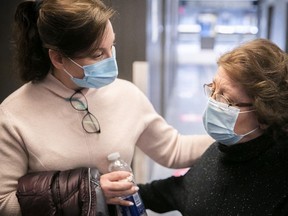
<box><xmin>107</xmin><ymin>152</ymin><xmax>147</xmax><ymax>216</ymax></box>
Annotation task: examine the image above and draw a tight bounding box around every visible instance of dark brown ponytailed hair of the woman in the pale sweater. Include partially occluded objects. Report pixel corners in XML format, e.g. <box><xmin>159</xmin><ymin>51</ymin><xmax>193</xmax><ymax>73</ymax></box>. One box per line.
<box><xmin>13</xmin><ymin>0</ymin><xmax>115</xmax><ymax>82</ymax></box>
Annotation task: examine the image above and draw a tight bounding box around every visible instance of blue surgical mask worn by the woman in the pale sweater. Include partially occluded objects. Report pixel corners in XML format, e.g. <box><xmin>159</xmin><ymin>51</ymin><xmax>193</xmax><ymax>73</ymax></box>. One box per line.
<box><xmin>64</xmin><ymin>46</ymin><xmax>118</xmax><ymax>88</ymax></box>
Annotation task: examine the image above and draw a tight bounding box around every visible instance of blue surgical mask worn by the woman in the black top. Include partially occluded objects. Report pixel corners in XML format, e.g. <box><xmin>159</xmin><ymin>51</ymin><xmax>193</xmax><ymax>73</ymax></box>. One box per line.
<box><xmin>203</xmin><ymin>98</ymin><xmax>258</xmax><ymax>145</ymax></box>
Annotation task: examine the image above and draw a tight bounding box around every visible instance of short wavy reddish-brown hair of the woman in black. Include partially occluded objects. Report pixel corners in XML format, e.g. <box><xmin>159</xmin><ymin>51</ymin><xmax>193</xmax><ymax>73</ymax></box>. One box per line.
<box><xmin>218</xmin><ymin>38</ymin><xmax>288</xmax><ymax>138</ymax></box>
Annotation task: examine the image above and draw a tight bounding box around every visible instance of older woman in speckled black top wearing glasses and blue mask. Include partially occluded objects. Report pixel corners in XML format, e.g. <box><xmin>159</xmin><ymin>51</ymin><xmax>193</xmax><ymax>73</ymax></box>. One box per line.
<box><xmin>140</xmin><ymin>39</ymin><xmax>288</xmax><ymax>216</ymax></box>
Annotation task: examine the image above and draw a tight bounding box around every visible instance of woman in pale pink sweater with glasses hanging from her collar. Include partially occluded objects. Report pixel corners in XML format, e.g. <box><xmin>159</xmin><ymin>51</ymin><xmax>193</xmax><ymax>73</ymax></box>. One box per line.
<box><xmin>0</xmin><ymin>0</ymin><xmax>212</xmax><ymax>216</ymax></box>
